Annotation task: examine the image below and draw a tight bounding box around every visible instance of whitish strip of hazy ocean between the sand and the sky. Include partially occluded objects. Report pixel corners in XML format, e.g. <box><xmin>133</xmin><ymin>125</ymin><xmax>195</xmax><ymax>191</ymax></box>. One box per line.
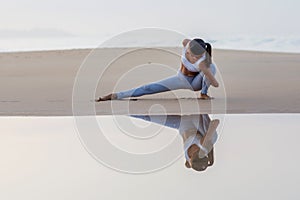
<box><xmin>0</xmin><ymin>36</ymin><xmax>300</xmax><ymax>53</ymax></box>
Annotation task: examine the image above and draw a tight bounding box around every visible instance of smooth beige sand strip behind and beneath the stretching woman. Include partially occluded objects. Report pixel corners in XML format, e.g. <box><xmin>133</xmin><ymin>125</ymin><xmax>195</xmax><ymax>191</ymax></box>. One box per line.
<box><xmin>0</xmin><ymin>48</ymin><xmax>300</xmax><ymax>116</ymax></box>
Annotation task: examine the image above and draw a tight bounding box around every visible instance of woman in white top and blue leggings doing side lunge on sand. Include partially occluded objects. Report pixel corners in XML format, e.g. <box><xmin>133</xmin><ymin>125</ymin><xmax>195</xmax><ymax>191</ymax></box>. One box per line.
<box><xmin>96</xmin><ymin>38</ymin><xmax>219</xmax><ymax>102</ymax></box>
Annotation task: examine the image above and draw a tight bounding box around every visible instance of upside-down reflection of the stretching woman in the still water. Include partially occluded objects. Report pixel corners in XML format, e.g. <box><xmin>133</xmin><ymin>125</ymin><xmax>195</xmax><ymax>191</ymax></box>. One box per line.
<box><xmin>131</xmin><ymin>114</ymin><xmax>219</xmax><ymax>171</ymax></box>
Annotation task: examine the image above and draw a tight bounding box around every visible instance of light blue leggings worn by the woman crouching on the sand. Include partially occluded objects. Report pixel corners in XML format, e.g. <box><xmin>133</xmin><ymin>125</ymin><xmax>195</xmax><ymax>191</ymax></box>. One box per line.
<box><xmin>116</xmin><ymin>64</ymin><xmax>216</xmax><ymax>99</ymax></box>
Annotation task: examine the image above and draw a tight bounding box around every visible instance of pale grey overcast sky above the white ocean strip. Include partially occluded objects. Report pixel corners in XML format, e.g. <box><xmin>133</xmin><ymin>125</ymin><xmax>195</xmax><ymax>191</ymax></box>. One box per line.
<box><xmin>0</xmin><ymin>0</ymin><xmax>300</xmax><ymax>37</ymax></box>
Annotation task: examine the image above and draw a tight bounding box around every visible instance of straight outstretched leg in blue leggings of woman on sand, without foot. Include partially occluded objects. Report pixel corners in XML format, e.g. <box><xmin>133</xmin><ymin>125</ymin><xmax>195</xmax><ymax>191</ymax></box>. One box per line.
<box><xmin>116</xmin><ymin>72</ymin><xmax>191</xmax><ymax>99</ymax></box>
